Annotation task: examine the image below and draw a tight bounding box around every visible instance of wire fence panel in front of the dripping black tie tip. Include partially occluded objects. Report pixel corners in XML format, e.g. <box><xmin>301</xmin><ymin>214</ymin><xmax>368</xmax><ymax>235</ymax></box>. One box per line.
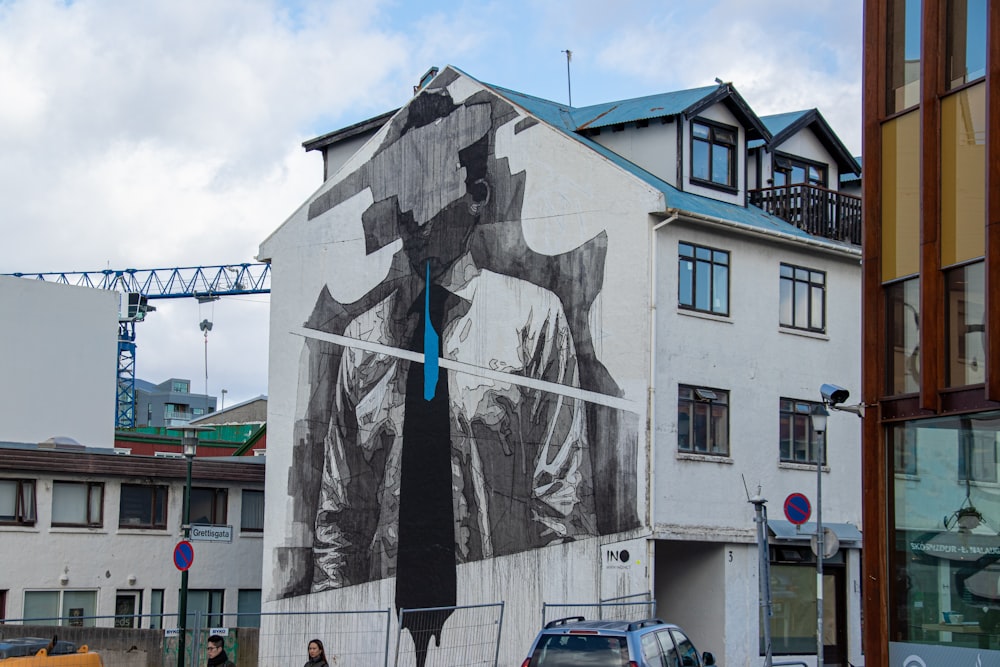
<box><xmin>393</xmin><ymin>602</ymin><xmax>504</xmax><ymax>667</ymax></box>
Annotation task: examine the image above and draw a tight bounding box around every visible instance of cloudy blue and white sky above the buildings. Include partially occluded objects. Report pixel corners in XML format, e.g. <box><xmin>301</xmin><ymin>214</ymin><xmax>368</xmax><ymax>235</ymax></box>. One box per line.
<box><xmin>0</xmin><ymin>0</ymin><xmax>862</xmax><ymax>406</ymax></box>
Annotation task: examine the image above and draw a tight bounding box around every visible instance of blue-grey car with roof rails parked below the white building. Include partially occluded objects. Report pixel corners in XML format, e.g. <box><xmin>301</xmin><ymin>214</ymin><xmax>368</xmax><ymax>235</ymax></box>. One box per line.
<box><xmin>521</xmin><ymin>616</ymin><xmax>715</xmax><ymax>667</ymax></box>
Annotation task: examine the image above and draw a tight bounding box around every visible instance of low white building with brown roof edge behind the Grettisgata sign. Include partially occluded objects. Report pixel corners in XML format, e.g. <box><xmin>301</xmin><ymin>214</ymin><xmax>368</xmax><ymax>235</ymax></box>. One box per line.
<box><xmin>0</xmin><ymin>440</ymin><xmax>264</xmax><ymax>628</ymax></box>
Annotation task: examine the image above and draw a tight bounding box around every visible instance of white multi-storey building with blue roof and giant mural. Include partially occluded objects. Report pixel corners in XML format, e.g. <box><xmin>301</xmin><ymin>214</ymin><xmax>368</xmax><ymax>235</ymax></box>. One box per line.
<box><xmin>260</xmin><ymin>67</ymin><xmax>863</xmax><ymax>665</ymax></box>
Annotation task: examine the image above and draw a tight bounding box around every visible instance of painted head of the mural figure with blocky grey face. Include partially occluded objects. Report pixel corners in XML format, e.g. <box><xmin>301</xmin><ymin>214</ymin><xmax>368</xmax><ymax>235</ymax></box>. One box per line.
<box><xmin>373</xmin><ymin>89</ymin><xmax>493</xmax><ymax>280</ymax></box>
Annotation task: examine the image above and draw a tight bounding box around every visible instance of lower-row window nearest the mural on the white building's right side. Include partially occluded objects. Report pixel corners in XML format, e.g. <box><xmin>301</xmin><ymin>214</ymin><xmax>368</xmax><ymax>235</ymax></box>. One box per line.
<box><xmin>677</xmin><ymin>385</ymin><xmax>729</xmax><ymax>456</ymax></box>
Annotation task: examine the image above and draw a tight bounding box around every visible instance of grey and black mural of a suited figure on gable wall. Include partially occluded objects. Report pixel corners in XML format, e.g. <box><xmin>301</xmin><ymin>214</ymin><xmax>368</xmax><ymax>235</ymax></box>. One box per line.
<box><xmin>276</xmin><ymin>70</ymin><xmax>638</xmax><ymax>664</ymax></box>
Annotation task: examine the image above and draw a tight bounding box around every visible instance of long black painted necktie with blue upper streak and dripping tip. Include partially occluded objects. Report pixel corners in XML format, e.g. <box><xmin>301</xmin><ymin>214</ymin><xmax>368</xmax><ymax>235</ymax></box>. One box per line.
<box><xmin>396</xmin><ymin>265</ymin><xmax>457</xmax><ymax>667</ymax></box>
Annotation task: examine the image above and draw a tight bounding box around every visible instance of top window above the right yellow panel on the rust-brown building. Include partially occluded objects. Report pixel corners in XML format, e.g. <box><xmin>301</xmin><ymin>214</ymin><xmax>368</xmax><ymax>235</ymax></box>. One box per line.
<box><xmin>945</xmin><ymin>0</ymin><xmax>987</xmax><ymax>90</ymax></box>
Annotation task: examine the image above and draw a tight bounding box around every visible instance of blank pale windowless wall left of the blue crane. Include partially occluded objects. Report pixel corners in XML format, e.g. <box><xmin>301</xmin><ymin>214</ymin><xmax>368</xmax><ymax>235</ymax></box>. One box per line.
<box><xmin>0</xmin><ymin>277</ymin><xmax>118</xmax><ymax>448</ymax></box>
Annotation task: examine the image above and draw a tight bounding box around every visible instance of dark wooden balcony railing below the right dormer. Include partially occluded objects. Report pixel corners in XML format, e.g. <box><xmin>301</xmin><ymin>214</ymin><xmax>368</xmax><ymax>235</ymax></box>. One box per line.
<box><xmin>750</xmin><ymin>184</ymin><xmax>861</xmax><ymax>245</ymax></box>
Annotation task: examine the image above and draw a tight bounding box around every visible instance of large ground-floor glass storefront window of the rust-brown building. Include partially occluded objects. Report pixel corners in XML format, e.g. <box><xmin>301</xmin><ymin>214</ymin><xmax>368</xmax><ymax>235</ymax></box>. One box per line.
<box><xmin>887</xmin><ymin>412</ymin><xmax>1000</xmax><ymax>648</ymax></box>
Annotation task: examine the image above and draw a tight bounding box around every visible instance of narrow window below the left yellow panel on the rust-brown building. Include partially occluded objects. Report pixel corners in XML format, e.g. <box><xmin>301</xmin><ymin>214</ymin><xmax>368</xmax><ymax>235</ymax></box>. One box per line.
<box><xmin>885</xmin><ymin>278</ymin><xmax>920</xmax><ymax>395</ymax></box>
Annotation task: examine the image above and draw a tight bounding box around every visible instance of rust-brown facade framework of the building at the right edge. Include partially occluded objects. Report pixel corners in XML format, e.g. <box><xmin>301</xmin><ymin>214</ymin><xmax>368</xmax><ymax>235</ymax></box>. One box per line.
<box><xmin>862</xmin><ymin>0</ymin><xmax>1000</xmax><ymax>667</ymax></box>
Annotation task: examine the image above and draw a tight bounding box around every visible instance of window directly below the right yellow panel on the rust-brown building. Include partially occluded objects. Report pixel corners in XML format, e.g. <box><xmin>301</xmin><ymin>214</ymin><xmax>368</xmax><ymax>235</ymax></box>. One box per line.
<box><xmin>945</xmin><ymin>262</ymin><xmax>986</xmax><ymax>387</ymax></box>
